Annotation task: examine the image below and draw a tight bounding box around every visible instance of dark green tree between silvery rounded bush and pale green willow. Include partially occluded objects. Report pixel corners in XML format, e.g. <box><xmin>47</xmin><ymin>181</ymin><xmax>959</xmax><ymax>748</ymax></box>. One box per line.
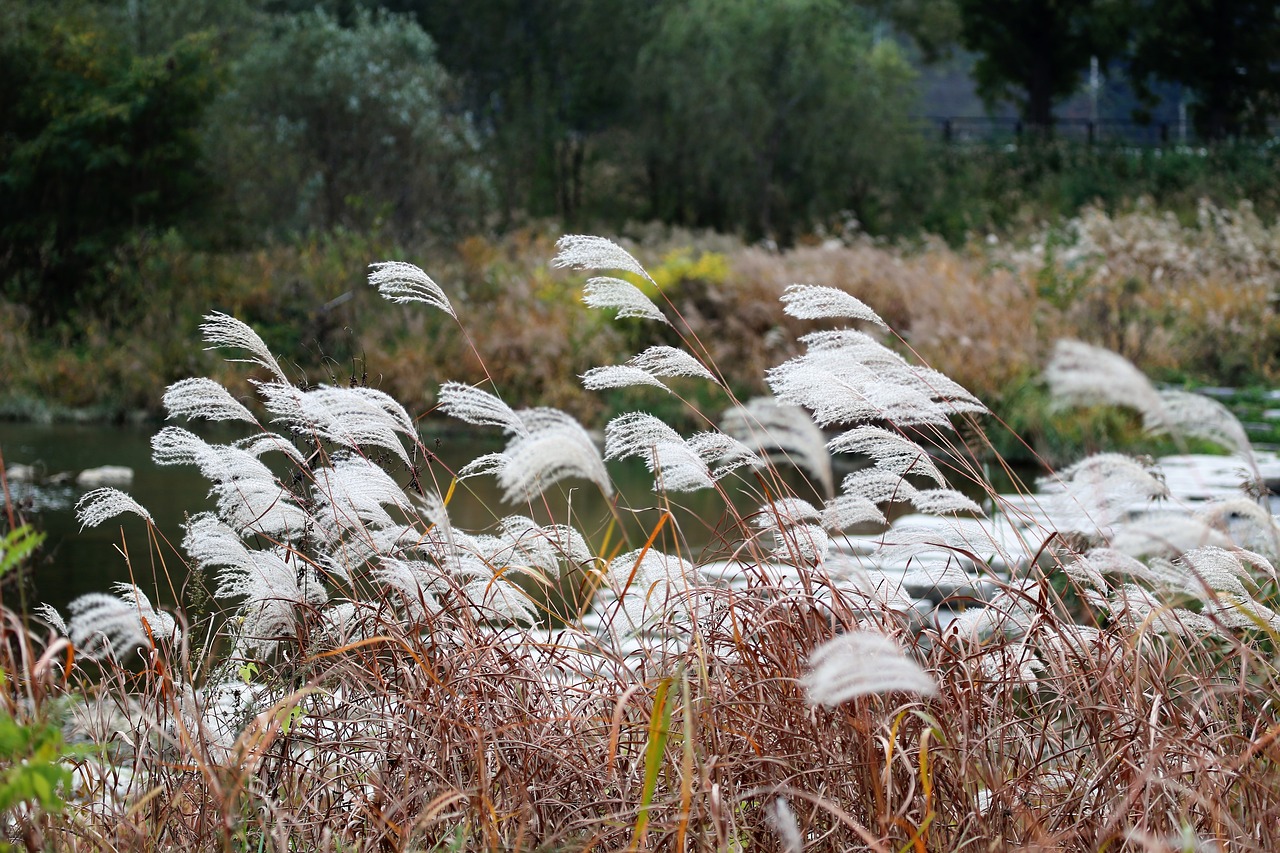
<box><xmin>378</xmin><ymin>0</ymin><xmax>653</xmax><ymax>219</ymax></box>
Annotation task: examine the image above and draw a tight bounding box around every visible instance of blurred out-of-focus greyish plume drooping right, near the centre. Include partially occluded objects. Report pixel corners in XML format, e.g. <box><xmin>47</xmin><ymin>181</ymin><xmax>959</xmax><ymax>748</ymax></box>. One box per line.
<box><xmin>719</xmin><ymin>397</ymin><xmax>836</xmax><ymax>496</ymax></box>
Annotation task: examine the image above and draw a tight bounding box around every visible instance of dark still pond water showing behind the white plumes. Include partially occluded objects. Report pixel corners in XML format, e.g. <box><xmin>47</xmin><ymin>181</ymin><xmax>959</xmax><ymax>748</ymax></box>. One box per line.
<box><xmin>0</xmin><ymin>423</ymin><xmax>815</xmax><ymax>610</ymax></box>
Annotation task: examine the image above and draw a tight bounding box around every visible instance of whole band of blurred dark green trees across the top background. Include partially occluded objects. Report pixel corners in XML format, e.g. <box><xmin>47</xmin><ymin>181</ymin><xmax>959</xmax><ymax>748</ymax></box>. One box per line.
<box><xmin>0</xmin><ymin>0</ymin><xmax>1280</xmax><ymax>328</ymax></box>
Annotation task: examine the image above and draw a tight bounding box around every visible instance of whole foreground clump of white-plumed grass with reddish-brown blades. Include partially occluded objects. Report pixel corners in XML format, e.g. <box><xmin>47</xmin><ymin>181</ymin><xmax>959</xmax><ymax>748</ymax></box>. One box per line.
<box><xmin>0</xmin><ymin>237</ymin><xmax>1280</xmax><ymax>850</ymax></box>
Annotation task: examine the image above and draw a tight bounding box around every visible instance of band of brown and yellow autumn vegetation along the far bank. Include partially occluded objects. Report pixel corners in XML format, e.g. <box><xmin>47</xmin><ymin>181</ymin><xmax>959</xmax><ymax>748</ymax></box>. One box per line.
<box><xmin>0</xmin><ymin>195</ymin><xmax>1280</xmax><ymax>464</ymax></box>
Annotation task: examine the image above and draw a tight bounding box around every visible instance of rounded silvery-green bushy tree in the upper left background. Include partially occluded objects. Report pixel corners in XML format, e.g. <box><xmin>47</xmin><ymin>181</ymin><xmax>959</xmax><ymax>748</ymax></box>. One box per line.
<box><xmin>210</xmin><ymin>9</ymin><xmax>486</xmax><ymax>237</ymax></box>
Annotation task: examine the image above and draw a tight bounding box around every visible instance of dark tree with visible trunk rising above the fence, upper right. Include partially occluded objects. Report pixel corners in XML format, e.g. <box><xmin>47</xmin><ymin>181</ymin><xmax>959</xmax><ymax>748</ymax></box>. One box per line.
<box><xmin>956</xmin><ymin>0</ymin><xmax>1121</xmax><ymax>129</ymax></box>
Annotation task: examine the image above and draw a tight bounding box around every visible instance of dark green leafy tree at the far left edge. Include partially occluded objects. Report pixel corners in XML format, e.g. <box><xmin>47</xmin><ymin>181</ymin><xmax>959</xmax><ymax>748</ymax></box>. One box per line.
<box><xmin>0</xmin><ymin>4</ymin><xmax>216</xmax><ymax>325</ymax></box>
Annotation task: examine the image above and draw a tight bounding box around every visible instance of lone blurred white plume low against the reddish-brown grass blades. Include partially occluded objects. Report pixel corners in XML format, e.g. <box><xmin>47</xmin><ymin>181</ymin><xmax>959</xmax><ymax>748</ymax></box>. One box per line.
<box><xmin>800</xmin><ymin>631</ymin><xmax>938</xmax><ymax>707</ymax></box>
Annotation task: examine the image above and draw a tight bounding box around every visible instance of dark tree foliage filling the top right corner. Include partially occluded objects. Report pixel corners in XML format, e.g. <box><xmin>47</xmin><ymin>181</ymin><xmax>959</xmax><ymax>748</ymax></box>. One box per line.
<box><xmin>1130</xmin><ymin>0</ymin><xmax>1280</xmax><ymax>140</ymax></box>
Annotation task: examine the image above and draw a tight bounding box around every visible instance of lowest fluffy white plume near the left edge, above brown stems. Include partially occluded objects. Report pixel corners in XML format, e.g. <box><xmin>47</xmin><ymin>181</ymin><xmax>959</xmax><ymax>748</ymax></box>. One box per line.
<box><xmin>67</xmin><ymin>583</ymin><xmax>178</xmax><ymax>657</ymax></box>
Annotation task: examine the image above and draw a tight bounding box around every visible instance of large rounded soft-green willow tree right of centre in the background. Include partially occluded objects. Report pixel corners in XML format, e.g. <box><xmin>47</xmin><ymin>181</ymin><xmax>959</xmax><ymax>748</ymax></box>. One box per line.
<box><xmin>637</xmin><ymin>0</ymin><xmax>916</xmax><ymax>241</ymax></box>
